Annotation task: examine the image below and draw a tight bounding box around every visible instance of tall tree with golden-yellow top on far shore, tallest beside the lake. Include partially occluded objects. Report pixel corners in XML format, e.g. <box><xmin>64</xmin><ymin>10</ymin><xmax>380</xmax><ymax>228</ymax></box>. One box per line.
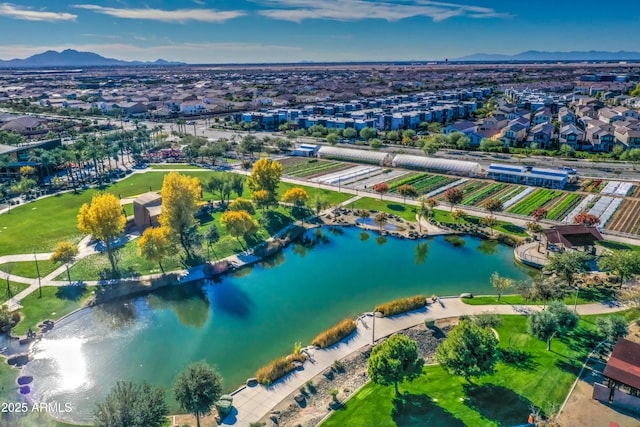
<box><xmin>159</xmin><ymin>172</ymin><xmax>202</xmax><ymax>260</ymax></box>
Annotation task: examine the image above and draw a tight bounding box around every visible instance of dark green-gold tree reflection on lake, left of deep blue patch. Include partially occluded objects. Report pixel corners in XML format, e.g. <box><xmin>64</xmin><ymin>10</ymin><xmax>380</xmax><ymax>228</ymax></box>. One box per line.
<box><xmin>149</xmin><ymin>284</ymin><xmax>209</xmax><ymax>328</ymax></box>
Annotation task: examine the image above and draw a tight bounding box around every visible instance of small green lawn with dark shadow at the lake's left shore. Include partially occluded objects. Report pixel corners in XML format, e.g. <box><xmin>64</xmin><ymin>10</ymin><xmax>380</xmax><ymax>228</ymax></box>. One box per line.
<box><xmin>13</xmin><ymin>286</ymin><xmax>95</xmax><ymax>335</ymax></box>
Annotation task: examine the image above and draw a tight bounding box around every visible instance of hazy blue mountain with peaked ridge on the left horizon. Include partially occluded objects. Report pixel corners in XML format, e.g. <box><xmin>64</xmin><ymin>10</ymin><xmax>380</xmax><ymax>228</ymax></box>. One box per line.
<box><xmin>0</xmin><ymin>49</ymin><xmax>184</xmax><ymax>68</ymax></box>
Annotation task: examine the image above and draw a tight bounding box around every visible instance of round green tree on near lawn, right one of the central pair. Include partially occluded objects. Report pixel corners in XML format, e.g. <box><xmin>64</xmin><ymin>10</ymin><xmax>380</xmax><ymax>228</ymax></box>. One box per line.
<box><xmin>435</xmin><ymin>320</ymin><xmax>498</xmax><ymax>382</ymax></box>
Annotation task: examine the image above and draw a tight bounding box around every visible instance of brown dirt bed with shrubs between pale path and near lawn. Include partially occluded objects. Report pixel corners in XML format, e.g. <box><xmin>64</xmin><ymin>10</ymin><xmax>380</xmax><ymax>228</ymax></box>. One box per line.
<box><xmin>260</xmin><ymin>324</ymin><xmax>452</xmax><ymax>427</ymax></box>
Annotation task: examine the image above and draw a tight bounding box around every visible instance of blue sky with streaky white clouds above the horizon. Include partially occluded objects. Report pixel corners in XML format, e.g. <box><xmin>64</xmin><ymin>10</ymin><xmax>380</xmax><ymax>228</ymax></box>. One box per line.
<box><xmin>0</xmin><ymin>0</ymin><xmax>640</xmax><ymax>63</ymax></box>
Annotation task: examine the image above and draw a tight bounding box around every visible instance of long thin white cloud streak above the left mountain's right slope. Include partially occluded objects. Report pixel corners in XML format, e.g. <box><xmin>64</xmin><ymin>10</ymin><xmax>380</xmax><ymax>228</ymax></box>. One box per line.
<box><xmin>73</xmin><ymin>4</ymin><xmax>246</xmax><ymax>23</ymax></box>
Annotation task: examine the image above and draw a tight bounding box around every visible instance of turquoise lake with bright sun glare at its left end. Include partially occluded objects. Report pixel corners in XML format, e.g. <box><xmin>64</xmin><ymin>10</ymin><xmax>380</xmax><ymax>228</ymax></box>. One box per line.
<box><xmin>24</xmin><ymin>228</ymin><xmax>532</xmax><ymax>422</ymax></box>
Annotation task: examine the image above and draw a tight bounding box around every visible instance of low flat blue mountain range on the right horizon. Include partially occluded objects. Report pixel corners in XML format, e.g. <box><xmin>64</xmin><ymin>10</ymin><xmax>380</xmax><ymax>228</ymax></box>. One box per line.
<box><xmin>453</xmin><ymin>50</ymin><xmax>640</xmax><ymax>62</ymax></box>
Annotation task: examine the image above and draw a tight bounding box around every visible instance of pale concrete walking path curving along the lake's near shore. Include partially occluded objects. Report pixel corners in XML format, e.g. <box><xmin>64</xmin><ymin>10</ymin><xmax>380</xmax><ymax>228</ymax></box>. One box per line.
<box><xmin>222</xmin><ymin>298</ymin><xmax>625</xmax><ymax>427</ymax></box>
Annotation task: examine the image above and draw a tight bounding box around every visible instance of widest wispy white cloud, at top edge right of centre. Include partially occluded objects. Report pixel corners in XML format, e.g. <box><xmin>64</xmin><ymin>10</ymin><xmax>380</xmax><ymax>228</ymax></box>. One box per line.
<box><xmin>258</xmin><ymin>0</ymin><xmax>508</xmax><ymax>23</ymax></box>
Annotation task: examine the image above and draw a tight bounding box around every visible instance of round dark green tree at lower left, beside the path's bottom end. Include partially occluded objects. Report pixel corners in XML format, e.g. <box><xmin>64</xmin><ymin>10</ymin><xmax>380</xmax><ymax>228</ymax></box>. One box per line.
<box><xmin>173</xmin><ymin>361</ymin><xmax>222</xmax><ymax>427</ymax></box>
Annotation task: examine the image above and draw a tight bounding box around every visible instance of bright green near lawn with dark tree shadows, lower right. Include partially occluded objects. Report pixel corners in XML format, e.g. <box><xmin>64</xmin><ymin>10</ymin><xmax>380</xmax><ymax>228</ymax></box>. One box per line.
<box><xmin>322</xmin><ymin>310</ymin><xmax>638</xmax><ymax>427</ymax></box>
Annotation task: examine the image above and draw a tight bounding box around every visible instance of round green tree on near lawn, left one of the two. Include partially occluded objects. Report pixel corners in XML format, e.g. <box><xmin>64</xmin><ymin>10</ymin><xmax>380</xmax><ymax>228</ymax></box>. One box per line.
<box><xmin>367</xmin><ymin>334</ymin><xmax>424</xmax><ymax>396</ymax></box>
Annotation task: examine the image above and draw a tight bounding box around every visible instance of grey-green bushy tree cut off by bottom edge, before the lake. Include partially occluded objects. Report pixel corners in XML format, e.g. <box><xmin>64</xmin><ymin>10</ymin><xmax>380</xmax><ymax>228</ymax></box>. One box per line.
<box><xmin>93</xmin><ymin>381</ymin><xmax>169</xmax><ymax>427</ymax></box>
